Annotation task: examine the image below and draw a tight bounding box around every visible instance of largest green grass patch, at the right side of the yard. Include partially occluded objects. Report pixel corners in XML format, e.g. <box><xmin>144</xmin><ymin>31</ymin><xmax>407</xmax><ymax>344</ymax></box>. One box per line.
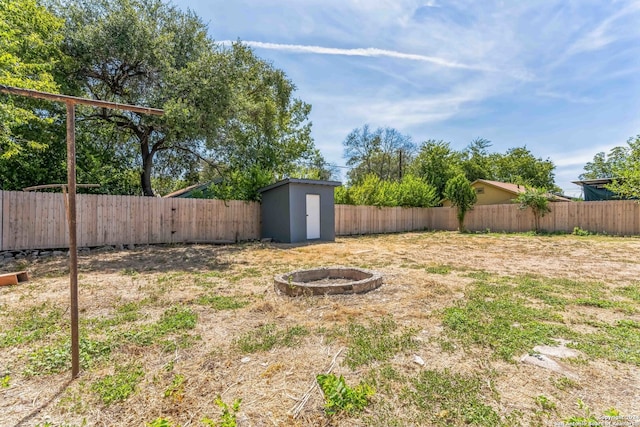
<box><xmin>442</xmin><ymin>276</ymin><xmax>640</xmax><ymax>365</ymax></box>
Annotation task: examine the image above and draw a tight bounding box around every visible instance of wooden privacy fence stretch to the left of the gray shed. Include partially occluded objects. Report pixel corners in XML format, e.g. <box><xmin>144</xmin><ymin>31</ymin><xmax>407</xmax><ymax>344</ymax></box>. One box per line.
<box><xmin>0</xmin><ymin>191</ymin><xmax>260</xmax><ymax>250</ymax></box>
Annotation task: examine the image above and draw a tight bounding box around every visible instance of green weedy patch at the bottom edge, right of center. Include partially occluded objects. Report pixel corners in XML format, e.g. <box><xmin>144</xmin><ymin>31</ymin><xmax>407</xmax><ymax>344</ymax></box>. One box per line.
<box><xmin>402</xmin><ymin>370</ymin><xmax>501</xmax><ymax>427</ymax></box>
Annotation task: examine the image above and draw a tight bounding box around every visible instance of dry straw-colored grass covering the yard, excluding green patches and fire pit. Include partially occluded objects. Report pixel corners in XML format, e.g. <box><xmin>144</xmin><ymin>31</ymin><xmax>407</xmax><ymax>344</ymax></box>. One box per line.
<box><xmin>0</xmin><ymin>232</ymin><xmax>640</xmax><ymax>426</ymax></box>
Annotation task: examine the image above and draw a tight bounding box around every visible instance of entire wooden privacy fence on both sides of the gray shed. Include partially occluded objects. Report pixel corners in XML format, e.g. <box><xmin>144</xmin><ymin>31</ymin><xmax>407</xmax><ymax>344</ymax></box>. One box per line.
<box><xmin>0</xmin><ymin>191</ymin><xmax>640</xmax><ymax>250</ymax></box>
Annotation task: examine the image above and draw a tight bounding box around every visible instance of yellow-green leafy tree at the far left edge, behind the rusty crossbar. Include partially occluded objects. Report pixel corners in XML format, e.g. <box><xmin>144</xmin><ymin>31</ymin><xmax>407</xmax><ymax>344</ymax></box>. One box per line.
<box><xmin>0</xmin><ymin>0</ymin><xmax>65</xmax><ymax>190</ymax></box>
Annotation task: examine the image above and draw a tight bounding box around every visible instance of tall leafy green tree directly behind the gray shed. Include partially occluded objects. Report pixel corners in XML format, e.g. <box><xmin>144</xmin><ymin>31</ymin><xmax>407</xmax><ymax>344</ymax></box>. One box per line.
<box><xmin>207</xmin><ymin>43</ymin><xmax>326</xmax><ymax>199</ymax></box>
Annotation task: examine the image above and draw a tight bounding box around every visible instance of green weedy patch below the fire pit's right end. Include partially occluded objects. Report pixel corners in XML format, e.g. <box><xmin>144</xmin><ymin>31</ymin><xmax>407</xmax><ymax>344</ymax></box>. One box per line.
<box><xmin>345</xmin><ymin>316</ymin><xmax>417</xmax><ymax>369</ymax></box>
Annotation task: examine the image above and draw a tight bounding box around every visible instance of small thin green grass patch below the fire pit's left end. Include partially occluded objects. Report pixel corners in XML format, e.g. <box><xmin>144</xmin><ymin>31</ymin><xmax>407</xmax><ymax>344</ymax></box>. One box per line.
<box><xmin>234</xmin><ymin>323</ymin><xmax>309</xmax><ymax>353</ymax></box>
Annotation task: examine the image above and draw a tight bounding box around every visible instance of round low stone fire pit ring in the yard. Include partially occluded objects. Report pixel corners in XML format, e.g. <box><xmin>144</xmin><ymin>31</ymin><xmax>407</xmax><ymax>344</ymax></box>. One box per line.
<box><xmin>274</xmin><ymin>267</ymin><xmax>382</xmax><ymax>297</ymax></box>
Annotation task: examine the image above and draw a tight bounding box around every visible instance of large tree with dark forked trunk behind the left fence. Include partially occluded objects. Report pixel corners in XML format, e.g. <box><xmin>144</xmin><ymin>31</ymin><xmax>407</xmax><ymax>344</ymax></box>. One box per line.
<box><xmin>59</xmin><ymin>0</ymin><xmax>226</xmax><ymax>195</ymax></box>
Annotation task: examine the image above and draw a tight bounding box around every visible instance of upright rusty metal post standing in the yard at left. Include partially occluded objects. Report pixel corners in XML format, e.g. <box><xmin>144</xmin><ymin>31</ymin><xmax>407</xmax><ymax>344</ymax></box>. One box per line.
<box><xmin>66</xmin><ymin>101</ymin><xmax>80</xmax><ymax>378</ymax></box>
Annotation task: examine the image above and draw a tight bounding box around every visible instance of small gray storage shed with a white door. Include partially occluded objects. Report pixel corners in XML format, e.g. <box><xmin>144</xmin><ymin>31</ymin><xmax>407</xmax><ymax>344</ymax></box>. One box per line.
<box><xmin>258</xmin><ymin>178</ymin><xmax>342</xmax><ymax>243</ymax></box>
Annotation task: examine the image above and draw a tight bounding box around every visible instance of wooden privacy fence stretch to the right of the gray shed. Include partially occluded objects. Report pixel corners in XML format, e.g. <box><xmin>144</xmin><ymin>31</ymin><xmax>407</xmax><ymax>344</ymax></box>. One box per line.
<box><xmin>336</xmin><ymin>200</ymin><xmax>640</xmax><ymax>236</ymax></box>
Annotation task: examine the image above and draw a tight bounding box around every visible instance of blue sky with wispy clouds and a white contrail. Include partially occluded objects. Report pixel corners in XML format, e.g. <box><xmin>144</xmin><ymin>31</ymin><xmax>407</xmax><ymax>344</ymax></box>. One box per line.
<box><xmin>174</xmin><ymin>0</ymin><xmax>640</xmax><ymax>195</ymax></box>
